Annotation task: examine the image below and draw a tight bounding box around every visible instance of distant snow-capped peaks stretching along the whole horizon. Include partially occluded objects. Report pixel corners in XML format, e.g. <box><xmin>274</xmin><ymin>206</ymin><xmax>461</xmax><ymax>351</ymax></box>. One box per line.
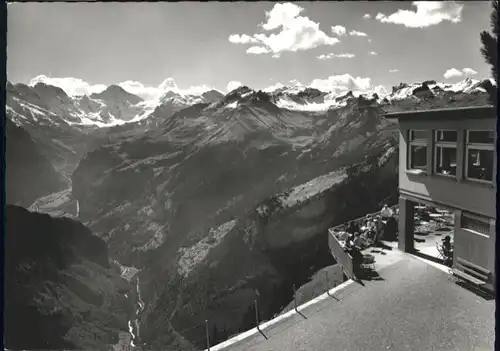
<box><xmin>7</xmin><ymin>78</ymin><xmax>495</xmax><ymax>127</ymax></box>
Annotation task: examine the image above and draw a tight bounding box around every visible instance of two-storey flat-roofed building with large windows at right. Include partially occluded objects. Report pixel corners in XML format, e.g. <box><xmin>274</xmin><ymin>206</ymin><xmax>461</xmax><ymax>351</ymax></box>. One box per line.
<box><xmin>385</xmin><ymin>106</ymin><xmax>497</xmax><ymax>290</ymax></box>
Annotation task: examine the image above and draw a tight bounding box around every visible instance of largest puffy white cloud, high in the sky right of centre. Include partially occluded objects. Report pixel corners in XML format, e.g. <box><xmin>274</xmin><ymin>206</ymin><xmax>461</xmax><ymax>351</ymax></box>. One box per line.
<box><xmin>229</xmin><ymin>3</ymin><xmax>339</xmax><ymax>55</ymax></box>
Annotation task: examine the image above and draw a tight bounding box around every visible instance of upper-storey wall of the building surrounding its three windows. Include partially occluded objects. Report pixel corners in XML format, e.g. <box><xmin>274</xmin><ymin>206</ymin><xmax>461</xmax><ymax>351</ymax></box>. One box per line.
<box><xmin>399</xmin><ymin>119</ymin><xmax>496</xmax><ymax>218</ymax></box>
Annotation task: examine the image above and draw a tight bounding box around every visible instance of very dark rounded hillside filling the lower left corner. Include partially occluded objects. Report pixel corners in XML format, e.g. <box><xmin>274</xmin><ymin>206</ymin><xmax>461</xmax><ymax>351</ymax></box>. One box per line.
<box><xmin>4</xmin><ymin>205</ymin><xmax>132</xmax><ymax>350</ymax></box>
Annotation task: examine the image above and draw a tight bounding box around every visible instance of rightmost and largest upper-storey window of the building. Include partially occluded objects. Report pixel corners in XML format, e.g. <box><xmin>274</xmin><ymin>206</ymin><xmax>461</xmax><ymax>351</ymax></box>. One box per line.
<box><xmin>465</xmin><ymin>130</ymin><xmax>495</xmax><ymax>182</ymax></box>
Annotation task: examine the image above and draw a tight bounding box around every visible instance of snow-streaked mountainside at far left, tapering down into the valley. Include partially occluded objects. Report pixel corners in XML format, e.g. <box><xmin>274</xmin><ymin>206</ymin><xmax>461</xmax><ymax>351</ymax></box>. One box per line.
<box><xmin>6</xmin><ymin>82</ymin><xmax>154</xmax><ymax>179</ymax></box>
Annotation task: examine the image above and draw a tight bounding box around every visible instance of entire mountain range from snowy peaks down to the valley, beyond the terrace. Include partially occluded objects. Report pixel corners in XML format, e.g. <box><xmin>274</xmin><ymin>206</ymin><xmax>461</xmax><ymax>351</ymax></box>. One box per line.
<box><xmin>7</xmin><ymin>75</ymin><xmax>495</xmax><ymax>350</ymax></box>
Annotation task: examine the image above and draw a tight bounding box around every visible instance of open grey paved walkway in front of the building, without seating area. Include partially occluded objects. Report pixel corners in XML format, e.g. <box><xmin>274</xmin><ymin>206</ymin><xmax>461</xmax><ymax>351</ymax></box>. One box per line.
<box><xmin>223</xmin><ymin>255</ymin><xmax>495</xmax><ymax>351</ymax></box>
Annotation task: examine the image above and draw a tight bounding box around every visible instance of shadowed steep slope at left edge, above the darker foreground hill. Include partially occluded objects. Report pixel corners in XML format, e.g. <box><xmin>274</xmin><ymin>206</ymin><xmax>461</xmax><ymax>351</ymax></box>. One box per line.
<box><xmin>5</xmin><ymin>119</ymin><xmax>68</xmax><ymax>207</ymax></box>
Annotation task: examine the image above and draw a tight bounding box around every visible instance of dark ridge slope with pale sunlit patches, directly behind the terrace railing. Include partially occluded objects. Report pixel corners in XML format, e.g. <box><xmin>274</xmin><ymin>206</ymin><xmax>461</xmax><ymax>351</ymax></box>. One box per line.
<box><xmin>141</xmin><ymin>145</ymin><xmax>398</xmax><ymax>349</ymax></box>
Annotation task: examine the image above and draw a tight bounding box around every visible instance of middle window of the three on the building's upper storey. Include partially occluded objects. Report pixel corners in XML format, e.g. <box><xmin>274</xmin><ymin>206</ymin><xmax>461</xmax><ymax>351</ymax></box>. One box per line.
<box><xmin>434</xmin><ymin>130</ymin><xmax>458</xmax><ymax>176</ymax></box>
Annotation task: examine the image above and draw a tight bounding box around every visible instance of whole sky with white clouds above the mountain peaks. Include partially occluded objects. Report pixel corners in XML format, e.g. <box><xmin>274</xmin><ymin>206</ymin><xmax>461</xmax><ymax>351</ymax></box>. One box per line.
<box><xmin>7</xmin><ymin>1</ymin><xmax>491</xmax><ymax>97</ymax></box>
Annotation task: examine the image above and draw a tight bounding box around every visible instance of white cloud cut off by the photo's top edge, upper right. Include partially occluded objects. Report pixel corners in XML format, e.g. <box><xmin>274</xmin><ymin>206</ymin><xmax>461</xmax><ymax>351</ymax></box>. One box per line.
<box><xmin>375</xmin><ymin>1</ymin><xmax>464</xmax><ymax>28</ymax></box>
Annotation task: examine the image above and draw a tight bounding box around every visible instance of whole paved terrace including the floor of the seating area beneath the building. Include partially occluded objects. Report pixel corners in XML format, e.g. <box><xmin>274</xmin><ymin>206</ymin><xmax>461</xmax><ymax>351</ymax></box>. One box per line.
<box><xmin>210</xmin><ymin>207</ymin><xmax>495</xmax><ymax>351</ymax></box>
